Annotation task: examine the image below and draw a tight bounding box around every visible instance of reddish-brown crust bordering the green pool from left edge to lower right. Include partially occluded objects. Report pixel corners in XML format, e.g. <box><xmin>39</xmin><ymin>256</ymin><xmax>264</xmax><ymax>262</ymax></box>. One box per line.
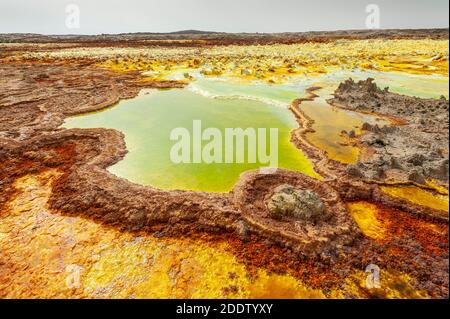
<box><xmin>0</xmin><ymin>33</ymin><xmax>448</xmax><ymax>297</ymax></box>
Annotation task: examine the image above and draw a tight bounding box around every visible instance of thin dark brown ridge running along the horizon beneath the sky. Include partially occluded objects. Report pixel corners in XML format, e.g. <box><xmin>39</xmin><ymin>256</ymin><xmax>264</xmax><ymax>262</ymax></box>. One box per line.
<box><xmin>0</xmin><ymin>28</ymin><xmax>449</xmax><ymax>45</ymax></box>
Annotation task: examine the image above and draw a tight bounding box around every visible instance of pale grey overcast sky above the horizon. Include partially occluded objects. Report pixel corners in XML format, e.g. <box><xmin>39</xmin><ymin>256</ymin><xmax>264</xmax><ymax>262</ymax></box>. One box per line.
<box><xmin>0</xmin><ymin>0</ymin><xmax>449</xmax><ymax>34</ymax></box>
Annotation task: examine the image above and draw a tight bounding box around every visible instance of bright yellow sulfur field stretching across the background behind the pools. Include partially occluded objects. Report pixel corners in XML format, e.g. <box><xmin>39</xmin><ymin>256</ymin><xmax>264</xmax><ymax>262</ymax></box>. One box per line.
<box><xmin>13</xmin><ymin>39</ymin><xmax>449</xmax><ymax>83</ymax></box>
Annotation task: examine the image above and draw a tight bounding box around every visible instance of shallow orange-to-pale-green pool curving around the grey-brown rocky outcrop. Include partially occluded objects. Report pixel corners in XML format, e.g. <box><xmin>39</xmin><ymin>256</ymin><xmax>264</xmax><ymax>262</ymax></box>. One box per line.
<box><xmin>300</xmin><ymin>72</ymin><xmax>448</xmax><ymax>164</ymax></box>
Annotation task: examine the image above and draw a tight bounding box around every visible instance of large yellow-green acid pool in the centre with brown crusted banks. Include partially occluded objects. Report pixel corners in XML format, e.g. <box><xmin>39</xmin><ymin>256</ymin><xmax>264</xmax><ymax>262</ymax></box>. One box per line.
<box><xmin>64</xmin><ymin>89</ymin><xmax>317</xmax><ymax>192</ymax></box>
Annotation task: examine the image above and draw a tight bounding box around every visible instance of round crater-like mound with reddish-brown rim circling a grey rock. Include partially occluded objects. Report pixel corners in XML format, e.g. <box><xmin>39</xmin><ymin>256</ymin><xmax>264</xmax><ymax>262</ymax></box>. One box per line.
<box><xmin>232</xmin><ymin>169</ymin><xmax>360</xmax><ymax>256</ymax></box>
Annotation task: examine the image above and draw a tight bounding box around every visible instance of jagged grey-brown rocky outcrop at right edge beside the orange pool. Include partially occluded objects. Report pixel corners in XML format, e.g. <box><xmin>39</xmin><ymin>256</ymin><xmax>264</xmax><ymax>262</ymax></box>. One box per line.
<box><xmin>329</xmin><ymin>79</ymin><xmax>449</xmax><ymax>188</ymax></box>
